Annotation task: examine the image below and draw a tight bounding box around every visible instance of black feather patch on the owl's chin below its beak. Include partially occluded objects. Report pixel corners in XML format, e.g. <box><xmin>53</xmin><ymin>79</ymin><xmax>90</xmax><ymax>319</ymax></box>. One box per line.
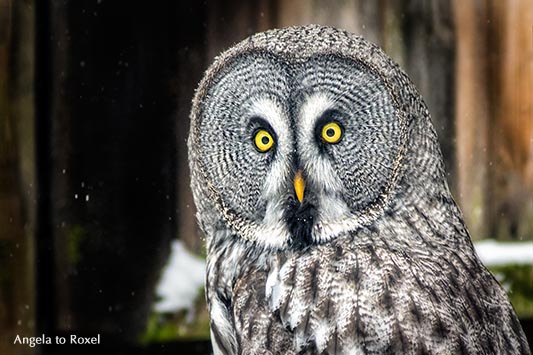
<box><xmin>285</xmin><ymin>198</ymin><xmax>317</xmax><ymax>249</ymax></box>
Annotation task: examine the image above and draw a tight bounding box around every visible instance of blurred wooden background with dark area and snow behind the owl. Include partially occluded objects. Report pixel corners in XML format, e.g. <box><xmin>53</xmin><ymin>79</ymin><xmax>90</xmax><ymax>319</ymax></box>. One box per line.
<box><xmin>0</xmin><ymin>0</ymin><xmax>533</xmax><ymax>355</ymax></box>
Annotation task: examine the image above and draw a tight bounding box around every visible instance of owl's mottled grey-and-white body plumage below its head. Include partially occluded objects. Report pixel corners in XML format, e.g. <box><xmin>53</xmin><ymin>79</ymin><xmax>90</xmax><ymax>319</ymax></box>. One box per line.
<box><xmin>209</xmin><ymin>209</ymin><xmax>527</xmax><ymax>354</ymax></box>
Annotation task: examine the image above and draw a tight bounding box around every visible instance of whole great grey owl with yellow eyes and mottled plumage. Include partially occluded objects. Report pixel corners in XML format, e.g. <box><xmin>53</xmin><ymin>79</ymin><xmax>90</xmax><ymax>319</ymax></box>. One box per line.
<box><xmin>188</xmin><ymin>25</ymin><xmax>530</xmax><ymax>354</ymax></box>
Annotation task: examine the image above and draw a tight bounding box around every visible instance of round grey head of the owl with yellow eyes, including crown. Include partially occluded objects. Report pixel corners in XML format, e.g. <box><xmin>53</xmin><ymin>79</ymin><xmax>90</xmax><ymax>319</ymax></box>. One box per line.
<box><xmin>188</xmin><ymin>25</ymin><xmax>447</xmax><ymax>248</ymax></box>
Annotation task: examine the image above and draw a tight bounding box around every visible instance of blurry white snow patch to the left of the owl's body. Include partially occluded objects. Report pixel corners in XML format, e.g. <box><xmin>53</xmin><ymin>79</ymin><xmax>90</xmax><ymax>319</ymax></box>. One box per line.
<box><xmin>155</xmin><ymin>240</ymin><xmax>205</xmax><ymax>315</ymax></box>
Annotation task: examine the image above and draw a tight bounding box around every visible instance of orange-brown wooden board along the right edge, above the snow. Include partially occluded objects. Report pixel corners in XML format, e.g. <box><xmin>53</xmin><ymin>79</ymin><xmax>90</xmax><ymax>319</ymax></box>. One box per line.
<box><xmin>487</xmin><ymin>0</ymin><xmax>533</xmax><ymax>240</ymax></box>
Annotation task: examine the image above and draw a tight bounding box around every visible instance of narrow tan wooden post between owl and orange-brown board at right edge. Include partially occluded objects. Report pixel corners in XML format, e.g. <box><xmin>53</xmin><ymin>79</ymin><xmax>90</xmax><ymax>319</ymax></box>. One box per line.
<box><xmin>453</xmin><ymin>0</ymin><xmax>490</xmax><ymax>239</ymax></box>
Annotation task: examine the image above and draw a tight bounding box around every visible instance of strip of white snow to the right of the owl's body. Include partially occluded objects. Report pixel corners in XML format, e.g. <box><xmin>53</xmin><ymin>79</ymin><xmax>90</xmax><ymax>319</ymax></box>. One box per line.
<box><xmin>474</xmin><ymin>239</ymin><xmax>533</xmax><ymax>266</ymax></box>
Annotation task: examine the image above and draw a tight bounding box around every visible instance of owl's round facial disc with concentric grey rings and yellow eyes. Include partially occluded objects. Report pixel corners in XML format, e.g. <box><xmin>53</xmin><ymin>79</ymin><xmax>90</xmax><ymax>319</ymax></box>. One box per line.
<box><xmin>197</xmin><ymin>51</ymin><xmax>401</xmax><ymax>247</ymax></box>
